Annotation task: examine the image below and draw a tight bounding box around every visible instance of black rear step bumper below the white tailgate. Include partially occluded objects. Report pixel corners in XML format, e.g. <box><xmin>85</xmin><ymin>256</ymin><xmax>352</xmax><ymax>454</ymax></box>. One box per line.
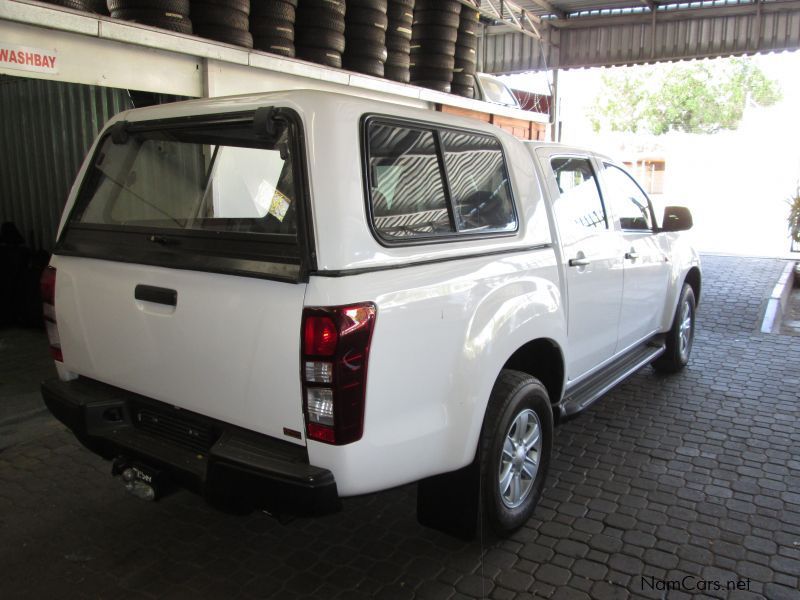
<box><xmin>42</xmin><ymin>378</ymin><xmax>340</xmax><ymax>515</ymax></box>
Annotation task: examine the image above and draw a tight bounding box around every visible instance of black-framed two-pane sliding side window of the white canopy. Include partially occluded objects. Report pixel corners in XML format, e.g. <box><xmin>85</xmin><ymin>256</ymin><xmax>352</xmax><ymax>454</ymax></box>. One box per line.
<box><xmin>366</xmin><ymin>120</ymin><xmax>517</xmax><ymax>243</ymax></box>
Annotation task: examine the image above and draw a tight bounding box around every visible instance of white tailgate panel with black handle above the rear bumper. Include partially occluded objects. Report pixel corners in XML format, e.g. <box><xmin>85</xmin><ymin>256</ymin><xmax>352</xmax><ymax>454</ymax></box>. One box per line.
<box><xmin>51</xmin><ymin>256</ymin><xmax>306</xmax><ymax>443</ymax></box>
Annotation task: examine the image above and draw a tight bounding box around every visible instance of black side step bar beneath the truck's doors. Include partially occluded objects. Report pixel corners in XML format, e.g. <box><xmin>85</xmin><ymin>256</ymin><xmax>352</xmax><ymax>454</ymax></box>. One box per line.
<box><xmin>559</xmin><ymin>336</ymin><xmax>666</xmax><ymax>422</ymax></box>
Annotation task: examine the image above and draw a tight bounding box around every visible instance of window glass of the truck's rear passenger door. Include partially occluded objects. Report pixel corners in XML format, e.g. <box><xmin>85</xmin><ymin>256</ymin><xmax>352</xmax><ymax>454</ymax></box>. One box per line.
<box><xmin>550</xmin><ymin>156</ymin><xmax>608</xmax><ymax>233</ymax></box>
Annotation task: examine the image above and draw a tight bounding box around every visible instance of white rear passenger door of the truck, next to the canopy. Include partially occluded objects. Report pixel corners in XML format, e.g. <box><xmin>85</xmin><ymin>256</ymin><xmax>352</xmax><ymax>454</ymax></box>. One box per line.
<box><xmin>537</xmin><ymin>148</ymin><xmax>623</xmax><ymax>381</ymax></box>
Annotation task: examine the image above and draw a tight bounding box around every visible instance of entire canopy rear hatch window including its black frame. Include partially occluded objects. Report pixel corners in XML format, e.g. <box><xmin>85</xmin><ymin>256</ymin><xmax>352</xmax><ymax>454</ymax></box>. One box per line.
<box><xmin>56</xmin><ymin>107</ymin><xmax>314</xmax><ymax>281</ymax></box>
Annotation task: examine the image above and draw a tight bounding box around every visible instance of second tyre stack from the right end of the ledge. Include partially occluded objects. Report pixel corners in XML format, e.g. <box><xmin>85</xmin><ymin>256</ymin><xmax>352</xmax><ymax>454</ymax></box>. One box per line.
<box><xmin>411</xmin><ymin>0</ymin><xmax>461</xmax><ymax>92</ymax></box>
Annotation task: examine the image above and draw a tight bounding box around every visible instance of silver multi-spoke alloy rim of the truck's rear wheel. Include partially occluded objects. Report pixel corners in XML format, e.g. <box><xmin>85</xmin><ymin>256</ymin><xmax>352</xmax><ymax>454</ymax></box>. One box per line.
<box><xmin>497</xmin><ymin>408</ymin><xmax>542</xmax><ymax>508</ymax></box>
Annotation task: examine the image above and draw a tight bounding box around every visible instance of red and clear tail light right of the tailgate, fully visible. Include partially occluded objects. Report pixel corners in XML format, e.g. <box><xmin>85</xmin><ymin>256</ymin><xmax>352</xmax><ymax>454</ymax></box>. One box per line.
<box><xmin>300</xmin><ymin>302</ymin><xmax>377</xmax><ymax>445</ymax></box>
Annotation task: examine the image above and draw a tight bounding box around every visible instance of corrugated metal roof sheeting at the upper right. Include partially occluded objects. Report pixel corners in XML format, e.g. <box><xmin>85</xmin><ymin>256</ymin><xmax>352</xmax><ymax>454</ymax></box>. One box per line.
<box><xmin>480</xmin><ymin>0</ymin><xmax>800</xmax><ymax>73</ymax></box>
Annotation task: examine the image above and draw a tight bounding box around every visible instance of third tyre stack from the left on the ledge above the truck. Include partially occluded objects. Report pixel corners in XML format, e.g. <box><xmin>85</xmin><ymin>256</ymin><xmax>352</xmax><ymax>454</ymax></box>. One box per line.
<box><xmin>192</xmin><ymin>0</ymin><xmax>253</xmax><ymax>48</ymax></box>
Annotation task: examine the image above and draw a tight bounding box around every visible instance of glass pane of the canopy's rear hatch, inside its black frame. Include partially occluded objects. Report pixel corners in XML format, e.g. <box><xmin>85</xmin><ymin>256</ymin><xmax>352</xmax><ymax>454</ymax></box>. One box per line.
<box><xmin>72</xmin><ymin>120</ymin><xmax>297</xmax><ymax>238</ymax></box>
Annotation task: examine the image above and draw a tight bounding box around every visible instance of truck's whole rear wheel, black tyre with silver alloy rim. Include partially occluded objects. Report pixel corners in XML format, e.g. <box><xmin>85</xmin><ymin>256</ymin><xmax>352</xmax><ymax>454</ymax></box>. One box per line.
<box><xmin>480</xmin><ymin>370</ymin><xmax>553</xmax><ymax>536</ymax></box>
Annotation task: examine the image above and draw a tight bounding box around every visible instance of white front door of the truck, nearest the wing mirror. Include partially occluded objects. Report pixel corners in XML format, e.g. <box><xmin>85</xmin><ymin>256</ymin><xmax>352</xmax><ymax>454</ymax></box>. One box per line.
<box><xmin>602</xmin><ymin>162</ymin><xmax>671</xmax><ymax>352</ymax></box>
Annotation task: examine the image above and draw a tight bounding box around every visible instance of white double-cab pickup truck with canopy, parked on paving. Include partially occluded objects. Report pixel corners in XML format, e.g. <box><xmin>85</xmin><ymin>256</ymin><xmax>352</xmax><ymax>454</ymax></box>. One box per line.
<box><xmin>42</xmin><ymin>91</ymin><xmax>700</xmax><ymax>535</ymax></box>
